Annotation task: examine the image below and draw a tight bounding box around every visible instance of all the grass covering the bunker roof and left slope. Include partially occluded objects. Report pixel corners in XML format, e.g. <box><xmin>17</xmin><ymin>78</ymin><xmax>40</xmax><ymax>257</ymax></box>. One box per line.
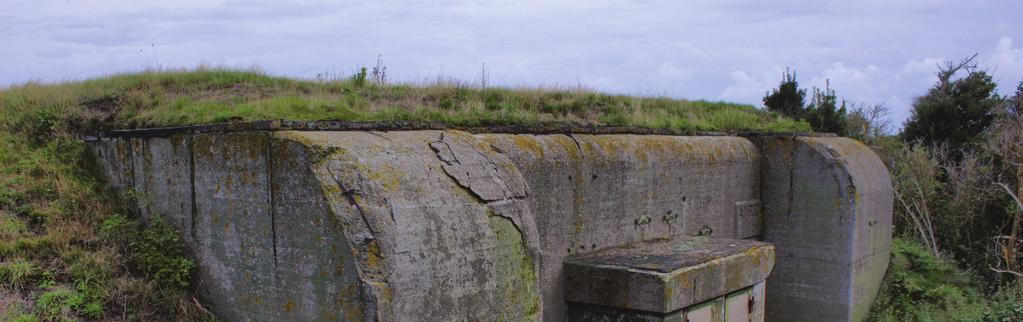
<box><xmin>0</xmin><ymin>68</ymin><xmax>809</xmax><ymax>321</ymax></box>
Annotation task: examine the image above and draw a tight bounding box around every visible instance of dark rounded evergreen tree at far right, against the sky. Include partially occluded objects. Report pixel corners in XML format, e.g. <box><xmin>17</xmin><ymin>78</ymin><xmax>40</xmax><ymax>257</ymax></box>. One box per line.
<box><xmin>902</xmin><ymin>55</ymin><xmax>1002</xmax><ymax>151</ymax></box>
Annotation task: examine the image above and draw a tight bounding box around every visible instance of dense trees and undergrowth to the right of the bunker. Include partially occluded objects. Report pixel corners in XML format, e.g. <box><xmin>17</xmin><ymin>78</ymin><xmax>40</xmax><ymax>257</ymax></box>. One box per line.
<box><xmin>764</xmin><ymin>55</ymin><xmax>1023</xmax><ymax>321</ymax></box>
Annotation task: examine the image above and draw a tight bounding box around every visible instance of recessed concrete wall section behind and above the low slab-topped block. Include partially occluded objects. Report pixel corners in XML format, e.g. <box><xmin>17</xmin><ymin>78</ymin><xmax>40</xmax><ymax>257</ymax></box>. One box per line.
<box><xmin>481</xmin><ymin>134</ymin><xmax>759</xmax><ymax>321</ymax></box>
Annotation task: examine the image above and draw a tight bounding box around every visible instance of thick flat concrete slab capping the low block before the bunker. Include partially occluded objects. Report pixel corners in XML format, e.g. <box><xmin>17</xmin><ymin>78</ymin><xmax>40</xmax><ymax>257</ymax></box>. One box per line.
<box><xmin>565</xmin><ymin>237</ymin><xmax>774</xmax><ymax>313</ymax></box>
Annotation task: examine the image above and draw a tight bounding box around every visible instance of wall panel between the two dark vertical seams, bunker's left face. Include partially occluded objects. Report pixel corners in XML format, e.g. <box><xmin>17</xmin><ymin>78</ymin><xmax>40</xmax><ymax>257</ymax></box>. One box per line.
<box><xmin>192</xmin><ymin>132</ymin><xmax>278</xmax><ymax>321</ymax></box>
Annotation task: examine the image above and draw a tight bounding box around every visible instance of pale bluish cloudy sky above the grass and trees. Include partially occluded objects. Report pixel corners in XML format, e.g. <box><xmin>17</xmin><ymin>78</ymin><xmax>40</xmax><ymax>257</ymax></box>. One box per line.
<box><xmin>0</xmin><ymin>0</ymin><xmax>1023</xmax><ymax>127</ymax></box>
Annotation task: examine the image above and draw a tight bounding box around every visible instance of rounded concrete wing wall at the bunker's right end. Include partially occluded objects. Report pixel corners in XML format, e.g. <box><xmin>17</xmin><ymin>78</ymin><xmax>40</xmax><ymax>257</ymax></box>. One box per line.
<box><xmin>760</xmin><ymin>137</ymin><xmax>892</xmax><ymax>321</ymax></box>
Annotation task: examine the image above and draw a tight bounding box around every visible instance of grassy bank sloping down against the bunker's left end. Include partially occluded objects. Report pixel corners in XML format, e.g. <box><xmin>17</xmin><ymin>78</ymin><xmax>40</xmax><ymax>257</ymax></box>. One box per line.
<box><xmin>0</xmin><ymin>71</ymin><xmax>211</xmax><ymax>321</ymax></box>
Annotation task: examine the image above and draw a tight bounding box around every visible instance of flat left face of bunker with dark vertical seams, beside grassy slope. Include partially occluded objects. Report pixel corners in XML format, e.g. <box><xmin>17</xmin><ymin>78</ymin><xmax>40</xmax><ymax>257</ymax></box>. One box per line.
<box><xmin>92</xmin><ymin>132</ymin><xmax>362</xmax><ymax>321</ymax></box>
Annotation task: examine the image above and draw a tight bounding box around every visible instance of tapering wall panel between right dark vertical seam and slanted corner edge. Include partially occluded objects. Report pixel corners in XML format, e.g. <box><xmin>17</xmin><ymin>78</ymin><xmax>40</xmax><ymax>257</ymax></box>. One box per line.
<box><xmin>270</xmin><ymin>135</ymin><xmax>365</xmax><ymax>321</ymax></box>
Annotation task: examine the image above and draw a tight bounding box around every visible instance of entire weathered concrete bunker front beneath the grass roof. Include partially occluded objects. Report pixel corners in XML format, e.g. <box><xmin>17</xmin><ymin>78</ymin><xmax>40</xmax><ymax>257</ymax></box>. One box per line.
<box><xmin>90</xmin><ymin>124</ymin><xmax>892</xmax><ymax>321</ymax></box>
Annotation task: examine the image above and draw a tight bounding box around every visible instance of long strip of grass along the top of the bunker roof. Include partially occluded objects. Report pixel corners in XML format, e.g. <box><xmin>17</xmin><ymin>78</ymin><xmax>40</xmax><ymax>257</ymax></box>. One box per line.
<box><xmin>0</xmin><ymin>67</ymin><xmax>809</xmax><ymax>132</ymax></box>
